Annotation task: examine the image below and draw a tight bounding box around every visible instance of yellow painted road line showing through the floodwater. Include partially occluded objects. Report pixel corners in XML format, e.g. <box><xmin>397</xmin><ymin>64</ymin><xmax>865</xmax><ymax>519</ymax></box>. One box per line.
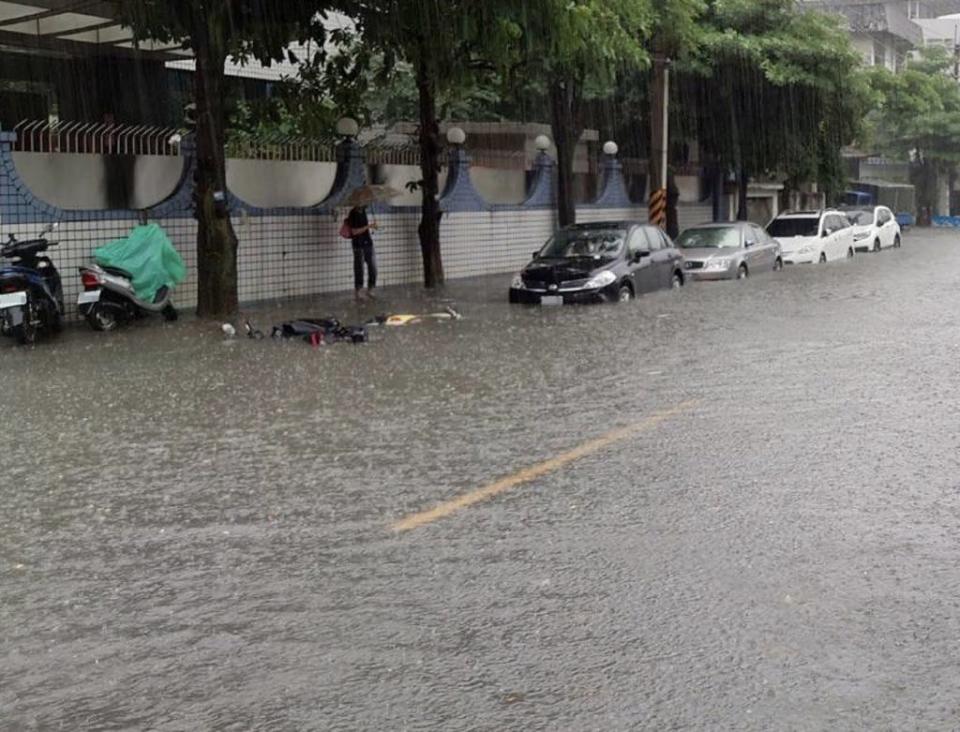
<box><xmin>390</xmin><ymin>401</ymin><xmax>697</xmax><ymax>533</ymax></box>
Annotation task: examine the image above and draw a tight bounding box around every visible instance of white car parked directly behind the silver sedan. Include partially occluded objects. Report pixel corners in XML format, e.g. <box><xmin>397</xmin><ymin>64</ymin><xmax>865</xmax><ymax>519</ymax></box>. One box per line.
<box><xmin>767</xmin><ymin>210</ymin><xmax>854</xmax><ymax>264</ymax></box>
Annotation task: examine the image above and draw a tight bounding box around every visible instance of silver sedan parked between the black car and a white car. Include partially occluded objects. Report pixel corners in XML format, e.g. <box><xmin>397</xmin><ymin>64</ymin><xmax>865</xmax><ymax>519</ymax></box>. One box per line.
<box><xmin>677</xmin><ymin>221</ymin><xmax>783</xmax><ymax>280</ymax></box>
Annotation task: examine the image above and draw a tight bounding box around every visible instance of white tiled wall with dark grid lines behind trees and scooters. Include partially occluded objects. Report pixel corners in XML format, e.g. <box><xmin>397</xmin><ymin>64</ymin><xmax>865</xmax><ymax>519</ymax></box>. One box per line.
<box><xmin>4</xmin><ymin>200</ymin><xmax>710</xmax><ymax>312</ymax></box>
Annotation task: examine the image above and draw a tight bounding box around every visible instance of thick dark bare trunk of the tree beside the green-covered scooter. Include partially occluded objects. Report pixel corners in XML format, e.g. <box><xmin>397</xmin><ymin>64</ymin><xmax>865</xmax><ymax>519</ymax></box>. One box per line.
<box><xmin>193</xmin><ymin>13</ymin><xmax>238</xmax><ymax>318</ymax></box>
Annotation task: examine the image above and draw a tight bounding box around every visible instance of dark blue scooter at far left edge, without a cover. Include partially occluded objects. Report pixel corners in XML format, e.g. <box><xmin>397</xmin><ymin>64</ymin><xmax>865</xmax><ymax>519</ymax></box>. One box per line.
<box><xmin>0</xmin><ymin>224</ymin><xmax>63</xmax><ymax>345</ymax></box>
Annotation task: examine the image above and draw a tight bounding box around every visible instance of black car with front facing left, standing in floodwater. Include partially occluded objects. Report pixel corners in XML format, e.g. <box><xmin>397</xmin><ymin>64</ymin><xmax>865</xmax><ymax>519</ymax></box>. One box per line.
<box><xmin>510</xmin><ymin>221</ymin><xmax>684</xmax><ymax>305</ymax></box>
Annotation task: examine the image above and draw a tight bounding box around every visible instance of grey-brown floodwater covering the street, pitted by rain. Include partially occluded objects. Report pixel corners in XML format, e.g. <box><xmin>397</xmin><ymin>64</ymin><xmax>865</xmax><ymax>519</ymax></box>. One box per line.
<box><xmin>0</xmin><ymin>227</ymin><xmax>960</xmax><ymax>730</ymax></box>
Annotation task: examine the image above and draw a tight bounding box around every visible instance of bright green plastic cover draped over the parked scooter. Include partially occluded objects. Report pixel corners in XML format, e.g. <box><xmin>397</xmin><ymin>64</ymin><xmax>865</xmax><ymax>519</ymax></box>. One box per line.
<box><xmin>93</xmin><ymin>224</ymin><xmax>187</xmax><ymax>302</ymax></box>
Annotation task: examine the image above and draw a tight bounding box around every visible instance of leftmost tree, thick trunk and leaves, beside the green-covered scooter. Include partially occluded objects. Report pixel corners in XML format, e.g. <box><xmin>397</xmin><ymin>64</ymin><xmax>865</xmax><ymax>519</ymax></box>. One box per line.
<box><xmin>118</xmin><ymin>0</ymin><xmax>326</xmax><ymax>317</ymax></box>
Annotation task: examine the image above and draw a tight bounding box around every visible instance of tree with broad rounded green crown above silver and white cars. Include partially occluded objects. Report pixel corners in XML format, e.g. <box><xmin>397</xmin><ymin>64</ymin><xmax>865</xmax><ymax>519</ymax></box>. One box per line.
<box><xmin>682</xmin><ymin>0</ymin><xmax>867</xmax><ymax>218</ymax></box>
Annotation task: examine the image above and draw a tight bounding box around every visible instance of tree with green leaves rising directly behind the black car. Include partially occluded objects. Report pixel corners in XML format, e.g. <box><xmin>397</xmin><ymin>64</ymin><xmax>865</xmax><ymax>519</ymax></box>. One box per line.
<box><xmin>507</xmin><ymin>0</ymin><xmax>654</xmax><ymax>226</ymax></box>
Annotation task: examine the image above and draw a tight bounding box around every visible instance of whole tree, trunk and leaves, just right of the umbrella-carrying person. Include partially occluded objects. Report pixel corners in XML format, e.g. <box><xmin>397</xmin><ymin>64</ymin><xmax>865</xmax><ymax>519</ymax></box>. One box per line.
<box><xmin>332</xmin><ymin>0</ymin><xmax>511</xmax><ymax>288</ymax></box>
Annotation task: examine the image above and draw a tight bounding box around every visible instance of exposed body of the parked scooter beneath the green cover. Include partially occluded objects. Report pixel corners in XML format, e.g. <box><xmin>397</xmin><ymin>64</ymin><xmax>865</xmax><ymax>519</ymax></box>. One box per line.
<box><xmin>77</xmin><ymin>264</ymin><xmax>177</xmax><ymax>331</ymax></box>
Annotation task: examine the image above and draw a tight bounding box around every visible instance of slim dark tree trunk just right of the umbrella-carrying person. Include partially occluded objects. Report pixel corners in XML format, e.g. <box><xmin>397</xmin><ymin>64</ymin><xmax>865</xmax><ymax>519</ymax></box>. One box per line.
<box><xmin>417</xmin><ymin>52</ymin><xmax>444</xmax><ymax>288</ymax></box>
